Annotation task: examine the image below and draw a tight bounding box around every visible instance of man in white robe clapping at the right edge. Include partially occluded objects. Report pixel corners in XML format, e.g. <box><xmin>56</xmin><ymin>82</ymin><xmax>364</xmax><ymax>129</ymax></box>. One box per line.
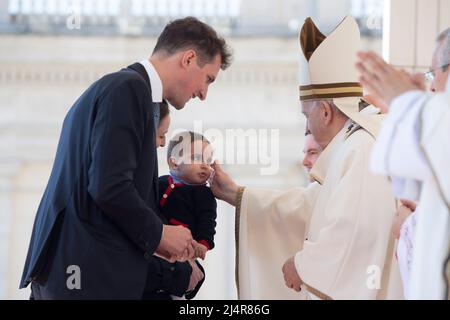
<box><xmin>357</xmin><ymin>28</ymin><xmax>450</xmax><ymax>299</ymax></box>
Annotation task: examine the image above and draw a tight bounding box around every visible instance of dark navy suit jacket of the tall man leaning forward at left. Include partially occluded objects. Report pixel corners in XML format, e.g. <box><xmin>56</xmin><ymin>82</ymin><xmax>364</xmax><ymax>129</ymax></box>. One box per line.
<box><xmin>20</xmin><ymin>63</ymin><xmax>192</xmax><ymax>299</ymax></box>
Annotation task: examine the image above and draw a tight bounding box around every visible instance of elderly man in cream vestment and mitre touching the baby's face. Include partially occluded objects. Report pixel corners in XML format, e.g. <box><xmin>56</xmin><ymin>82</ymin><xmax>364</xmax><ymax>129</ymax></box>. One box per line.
<box><xmin>212</xmin><ymin>17</ymin><xmax>402</xmax><ymax>299</ymax></box>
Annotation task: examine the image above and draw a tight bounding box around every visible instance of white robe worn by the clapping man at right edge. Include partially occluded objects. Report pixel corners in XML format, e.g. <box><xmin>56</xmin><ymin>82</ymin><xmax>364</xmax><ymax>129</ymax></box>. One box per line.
<box><xmin>371</xmin><ymin>81</ymin><xmax>450</xmax><ymax>299</ymax></box>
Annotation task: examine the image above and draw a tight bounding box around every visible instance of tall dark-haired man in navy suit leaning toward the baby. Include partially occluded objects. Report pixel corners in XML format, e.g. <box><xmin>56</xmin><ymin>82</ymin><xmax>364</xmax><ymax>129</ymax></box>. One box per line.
<box><xmin>20</xmin><ymin>17</ymin><xmax>230</xmax><ymax>299</ymax></box>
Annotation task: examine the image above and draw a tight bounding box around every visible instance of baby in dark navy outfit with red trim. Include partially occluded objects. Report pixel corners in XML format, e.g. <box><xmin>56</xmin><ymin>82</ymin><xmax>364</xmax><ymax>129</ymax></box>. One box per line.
<box><xmin>159</xmin><ymin>131</ymin><xmax>217</xmax><ymax>298</ymax></box>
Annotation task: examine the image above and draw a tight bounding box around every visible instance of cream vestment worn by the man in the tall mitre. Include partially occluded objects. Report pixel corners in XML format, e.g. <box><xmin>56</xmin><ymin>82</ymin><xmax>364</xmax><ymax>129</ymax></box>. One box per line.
<box><xmin>237</xmin><ymin>123</ymin><xmax>402</xmax><ymax>299</ymax></box>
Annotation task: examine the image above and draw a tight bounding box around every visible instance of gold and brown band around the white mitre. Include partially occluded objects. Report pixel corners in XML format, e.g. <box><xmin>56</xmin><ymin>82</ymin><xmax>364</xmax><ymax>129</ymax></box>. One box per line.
<box><xmin>299</xmin><ymin>82</ymin><xmax>363</xmax><ymax>101</ymax></box>
